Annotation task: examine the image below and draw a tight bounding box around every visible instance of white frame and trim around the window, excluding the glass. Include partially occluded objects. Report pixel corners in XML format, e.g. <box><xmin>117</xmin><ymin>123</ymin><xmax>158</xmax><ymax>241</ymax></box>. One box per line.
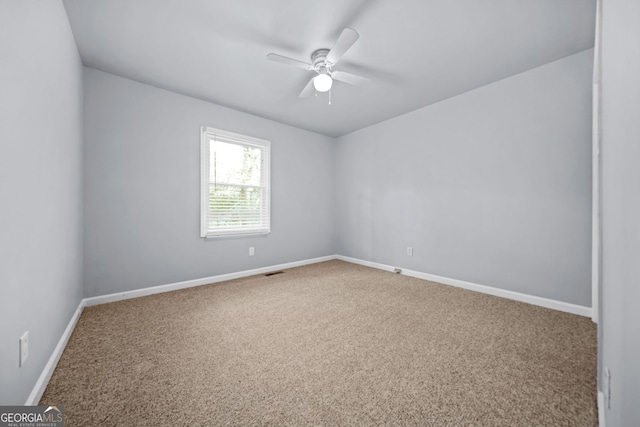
<box><xmin>200</xmin><ymin>126</ymin><xmax>271</xmax><ymax>238</ymax></box>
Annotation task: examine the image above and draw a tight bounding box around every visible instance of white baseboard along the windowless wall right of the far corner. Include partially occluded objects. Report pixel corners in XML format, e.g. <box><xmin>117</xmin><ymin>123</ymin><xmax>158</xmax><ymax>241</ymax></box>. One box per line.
<box><xmin>336</xmin><ymin>255</ymin><xmax>592</xmax><ymax>317</ymax></box>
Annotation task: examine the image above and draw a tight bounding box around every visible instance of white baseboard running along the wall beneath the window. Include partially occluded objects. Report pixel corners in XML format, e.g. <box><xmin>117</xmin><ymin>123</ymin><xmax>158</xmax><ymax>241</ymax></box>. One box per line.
<box><xmin>84</xmin><ymin>255</ymin><xmax>336</xmax><ymax>307</ymax></box>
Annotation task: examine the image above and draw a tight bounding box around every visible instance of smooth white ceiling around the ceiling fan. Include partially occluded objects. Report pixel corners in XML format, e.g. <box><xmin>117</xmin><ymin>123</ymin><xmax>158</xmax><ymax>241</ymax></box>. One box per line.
<box><xmin>64</xmin><ymin>0</ymin><xmax>595</xmax><ymax>137</ymax></box>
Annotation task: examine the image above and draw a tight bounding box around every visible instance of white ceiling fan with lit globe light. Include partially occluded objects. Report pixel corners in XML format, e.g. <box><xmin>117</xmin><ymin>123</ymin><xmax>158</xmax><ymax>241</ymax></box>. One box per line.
<box><xmin>267</xmin><ymin>28</ymin><xmax>369</xmax><ymax>98</ymax></box>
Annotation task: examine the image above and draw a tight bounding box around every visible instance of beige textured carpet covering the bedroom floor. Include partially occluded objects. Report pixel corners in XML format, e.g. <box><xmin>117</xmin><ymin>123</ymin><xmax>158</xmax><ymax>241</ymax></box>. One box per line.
<box><xmin>40</xmin><ymin>261</ymin><xmax>597</xmax><ymax>427</ymax></box>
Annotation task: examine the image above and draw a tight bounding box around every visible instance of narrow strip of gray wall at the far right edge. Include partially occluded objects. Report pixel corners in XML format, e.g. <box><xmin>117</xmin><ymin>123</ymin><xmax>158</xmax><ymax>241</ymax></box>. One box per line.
<box><xmin>599</xmin><ymin>0</ymin><xmax>640</xmax><ymax>427</ymax></box>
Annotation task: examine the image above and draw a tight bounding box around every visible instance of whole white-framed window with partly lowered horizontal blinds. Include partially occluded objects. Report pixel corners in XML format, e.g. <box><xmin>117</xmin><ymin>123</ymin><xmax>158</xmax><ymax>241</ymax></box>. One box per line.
<box><xmin>200</xmin><ymin>126</ymin><xmax>271</xmax><ymax>241</ymax></box>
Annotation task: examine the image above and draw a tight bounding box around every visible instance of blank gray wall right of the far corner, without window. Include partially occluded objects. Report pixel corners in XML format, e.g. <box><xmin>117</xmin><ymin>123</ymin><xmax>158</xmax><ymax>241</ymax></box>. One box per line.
<box><xmin>336</xmin><ymin>50</ymin><xmax>593</xmax><ymax>306</ymax></box>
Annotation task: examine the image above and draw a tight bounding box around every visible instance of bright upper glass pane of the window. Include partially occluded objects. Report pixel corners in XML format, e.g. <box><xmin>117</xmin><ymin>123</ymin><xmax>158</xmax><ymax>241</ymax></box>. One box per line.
<box><xmin>209</xmin><ymin>141</ymin><xmax>262</xmax><ymax>186</ymax></box>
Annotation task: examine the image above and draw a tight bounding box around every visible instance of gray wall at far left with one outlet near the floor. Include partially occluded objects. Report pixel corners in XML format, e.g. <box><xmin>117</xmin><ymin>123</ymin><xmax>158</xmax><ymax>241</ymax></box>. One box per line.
<box><xmin>0</xmin><ymin>0</ymin><xmax>82</xmax><ymax>405</ymax></box>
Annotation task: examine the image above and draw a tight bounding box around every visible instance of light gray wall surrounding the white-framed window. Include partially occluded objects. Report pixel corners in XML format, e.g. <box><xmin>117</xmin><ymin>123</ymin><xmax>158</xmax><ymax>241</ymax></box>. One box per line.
<box><xmin>84</xmin><ymin>68</ymin><xmax>334</xmax><ymax>297</ymax></box>
